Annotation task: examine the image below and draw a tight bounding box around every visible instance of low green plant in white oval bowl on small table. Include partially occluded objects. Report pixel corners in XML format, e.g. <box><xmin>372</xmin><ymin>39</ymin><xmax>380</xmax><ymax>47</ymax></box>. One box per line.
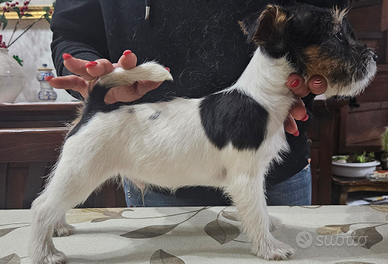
<box><xmin>332</xmin><ymin>152</ymin><xmax>380</xmax><ymax>178</ymax></box>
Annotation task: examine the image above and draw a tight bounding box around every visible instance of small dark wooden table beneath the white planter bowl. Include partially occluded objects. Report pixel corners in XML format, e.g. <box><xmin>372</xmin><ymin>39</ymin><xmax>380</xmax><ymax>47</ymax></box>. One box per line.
<box><xmin>333</xmin><ymin>176</ymin><xmax>388</xmax><ymax>205</ymax></box>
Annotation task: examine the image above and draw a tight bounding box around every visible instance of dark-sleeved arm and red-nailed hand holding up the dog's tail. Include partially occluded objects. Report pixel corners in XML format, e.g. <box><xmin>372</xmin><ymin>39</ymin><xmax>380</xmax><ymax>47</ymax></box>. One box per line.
<box><xmin>47</xmin><ymin>0</ymin><xmax>161</xmax><ymax>103</ymax></box>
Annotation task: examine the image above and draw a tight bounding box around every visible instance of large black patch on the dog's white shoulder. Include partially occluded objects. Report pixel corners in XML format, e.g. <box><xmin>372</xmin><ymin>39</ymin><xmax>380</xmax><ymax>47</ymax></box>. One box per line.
<box><xmin>200</xmin><ymin>90</ymin><xmax>269</xmax><ymax>150</ymax></box>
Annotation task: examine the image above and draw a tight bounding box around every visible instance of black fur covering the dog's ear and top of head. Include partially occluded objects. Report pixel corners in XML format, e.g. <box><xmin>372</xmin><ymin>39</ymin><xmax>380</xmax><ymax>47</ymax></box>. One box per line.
<box><xmin>240</xmin><ymin>5</ymin><xmax>333</xmax><ymax>65</ymax></box>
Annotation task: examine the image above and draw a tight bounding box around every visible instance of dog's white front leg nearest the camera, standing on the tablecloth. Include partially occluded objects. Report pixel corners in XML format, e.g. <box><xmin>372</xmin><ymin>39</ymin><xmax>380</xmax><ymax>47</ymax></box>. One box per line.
<box><xmin>226</xmin><ymin>175</ymin><xmax>294</xmax><ymax>260</ymax></box>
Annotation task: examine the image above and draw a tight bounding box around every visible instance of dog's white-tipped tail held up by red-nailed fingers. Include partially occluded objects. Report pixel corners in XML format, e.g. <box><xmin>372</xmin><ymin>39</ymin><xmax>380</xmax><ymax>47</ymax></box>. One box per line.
<box><xmin>87</xmin><ymin>62</ymin><xmax>173</xmax><ymax>110</ymax></box>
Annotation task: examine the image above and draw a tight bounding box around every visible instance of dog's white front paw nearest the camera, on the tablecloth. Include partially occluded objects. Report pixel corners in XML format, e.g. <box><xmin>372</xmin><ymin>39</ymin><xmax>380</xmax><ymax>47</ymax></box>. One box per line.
<box><xmin>252</xmin><ymin>239</ymin><xmax>295</xmax><ymax>260</ymax></box>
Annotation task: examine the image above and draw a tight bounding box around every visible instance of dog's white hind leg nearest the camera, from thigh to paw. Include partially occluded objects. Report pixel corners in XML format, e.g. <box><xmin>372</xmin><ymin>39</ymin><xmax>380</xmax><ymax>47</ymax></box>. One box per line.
<box><xmin>30</xmin><ymin>150</ymin><xmax>111</xmax><ymax>264</ymax></box>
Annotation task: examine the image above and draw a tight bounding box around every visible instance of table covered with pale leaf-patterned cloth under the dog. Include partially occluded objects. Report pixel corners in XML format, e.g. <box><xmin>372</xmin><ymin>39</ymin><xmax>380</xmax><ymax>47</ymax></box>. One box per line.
<box><xmin>0</xmin><ymin>206</ymin><xmax>388</xmax><ymax>264</ymax></box>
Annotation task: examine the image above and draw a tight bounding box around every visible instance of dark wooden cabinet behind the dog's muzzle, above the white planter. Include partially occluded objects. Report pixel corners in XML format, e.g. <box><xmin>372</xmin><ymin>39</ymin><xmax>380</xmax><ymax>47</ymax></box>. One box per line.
<box><xmin>334</xmin><ymin>0</ymin><xmax>388</xmax><ymax>154</ymax></box>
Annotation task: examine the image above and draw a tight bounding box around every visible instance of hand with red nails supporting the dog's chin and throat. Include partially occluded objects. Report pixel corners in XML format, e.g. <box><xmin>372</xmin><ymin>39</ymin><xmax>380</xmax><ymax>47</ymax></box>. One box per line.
<box><xmin>284</xmin><ymin>73</ymin><xmax>327</xmax><ymax>136</ymax></box>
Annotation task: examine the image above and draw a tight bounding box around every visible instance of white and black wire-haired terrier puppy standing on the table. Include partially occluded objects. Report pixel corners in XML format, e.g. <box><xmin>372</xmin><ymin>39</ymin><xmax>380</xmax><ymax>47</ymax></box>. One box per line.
<box><xmin>30</xmin><ymin>5</ymin><xmax>376</xmax><ymax>263</ymax></box>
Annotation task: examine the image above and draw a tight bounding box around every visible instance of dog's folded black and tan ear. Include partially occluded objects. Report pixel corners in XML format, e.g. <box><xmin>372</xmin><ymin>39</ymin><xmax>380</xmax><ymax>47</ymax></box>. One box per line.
<box><xmin>239</xmin><ymin>5</ymin><xmax>290</xmax><ymax>56</ymax></box>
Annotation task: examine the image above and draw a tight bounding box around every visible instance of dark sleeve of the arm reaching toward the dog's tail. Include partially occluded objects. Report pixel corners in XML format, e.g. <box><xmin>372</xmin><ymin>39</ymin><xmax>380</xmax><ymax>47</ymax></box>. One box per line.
<box><xmin>51</xmin><ymin>0</ymin><xmax>109</xmax><ymax>99</ymax></box>
